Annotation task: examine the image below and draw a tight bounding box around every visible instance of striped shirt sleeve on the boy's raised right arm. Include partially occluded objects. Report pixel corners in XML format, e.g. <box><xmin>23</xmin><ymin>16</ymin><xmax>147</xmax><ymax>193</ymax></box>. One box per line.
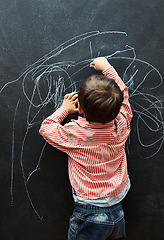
<box><xmin>103</xmin><ymin>66</ymin><xmax>132</xmax><ymax>126</ymax></box>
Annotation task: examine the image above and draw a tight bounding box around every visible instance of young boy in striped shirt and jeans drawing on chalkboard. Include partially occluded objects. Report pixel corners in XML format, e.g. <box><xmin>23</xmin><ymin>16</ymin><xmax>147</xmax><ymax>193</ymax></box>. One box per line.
<box><xmin>40</xmin><ymin>57</ymin><xmax>132</xmax><ymax>240</ymax></box>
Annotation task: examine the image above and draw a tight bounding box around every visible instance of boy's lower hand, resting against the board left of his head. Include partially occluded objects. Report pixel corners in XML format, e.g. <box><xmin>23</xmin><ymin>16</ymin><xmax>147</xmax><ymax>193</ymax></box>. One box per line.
<box><xmin>61</xmin><ymin>92</ymin><xmax>78</xmax><ymax>114</ymax></box>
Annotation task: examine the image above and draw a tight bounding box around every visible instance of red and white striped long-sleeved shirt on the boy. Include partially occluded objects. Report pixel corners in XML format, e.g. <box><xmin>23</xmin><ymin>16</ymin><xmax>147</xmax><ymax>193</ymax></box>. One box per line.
<box><xmin>39</xmin><ymin>66</ymin><xmax>132</xmax><ymax>199</ymax></box>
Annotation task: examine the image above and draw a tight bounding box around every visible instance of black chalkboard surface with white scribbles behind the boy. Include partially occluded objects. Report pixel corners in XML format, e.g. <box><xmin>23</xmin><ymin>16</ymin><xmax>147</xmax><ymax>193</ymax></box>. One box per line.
<box><xmin>0</xmin><ymin>0</ymin><xmax>164</xmax><ymax>240</ymax></box>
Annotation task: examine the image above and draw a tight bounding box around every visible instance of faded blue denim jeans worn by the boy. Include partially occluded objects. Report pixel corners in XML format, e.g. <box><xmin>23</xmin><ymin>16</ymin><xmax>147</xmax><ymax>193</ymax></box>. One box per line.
<box><xmin>68</xmin><ymin>203</ymin><xmax>126</xmax><ymax>240</ymax></box>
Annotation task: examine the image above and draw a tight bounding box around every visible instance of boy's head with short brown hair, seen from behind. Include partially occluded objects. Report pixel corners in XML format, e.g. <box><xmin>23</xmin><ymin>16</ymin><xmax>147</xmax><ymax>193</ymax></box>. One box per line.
<box><xmin>78</xmin><ymin>75</ymin><xmax>123</xmax><ymax>124</ymax></box>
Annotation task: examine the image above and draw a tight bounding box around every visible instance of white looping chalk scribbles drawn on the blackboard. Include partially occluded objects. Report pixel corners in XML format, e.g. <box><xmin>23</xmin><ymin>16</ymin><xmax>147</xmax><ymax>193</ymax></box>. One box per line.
<box><xmin>0</xmin><ymin>31</ymin><xmax>164</xmax><ymax>220</ymax></box>
